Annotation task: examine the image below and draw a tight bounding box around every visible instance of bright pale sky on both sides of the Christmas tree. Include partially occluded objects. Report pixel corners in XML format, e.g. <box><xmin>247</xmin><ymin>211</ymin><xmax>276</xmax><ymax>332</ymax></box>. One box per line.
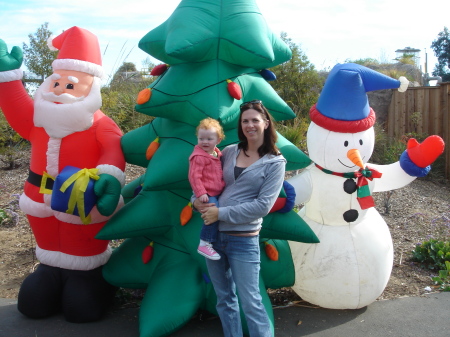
<box><xmin>0</xmin><ymin>0</ymin><xmax>450</xmax><ymax>84</ymax></box>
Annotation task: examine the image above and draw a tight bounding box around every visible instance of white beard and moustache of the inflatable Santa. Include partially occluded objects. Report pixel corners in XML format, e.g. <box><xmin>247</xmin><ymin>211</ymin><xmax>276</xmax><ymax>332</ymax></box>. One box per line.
<box><xmin>34</xmin><ymin>77</ymin><xmax>102</xmax><ymax>138</ymax></box>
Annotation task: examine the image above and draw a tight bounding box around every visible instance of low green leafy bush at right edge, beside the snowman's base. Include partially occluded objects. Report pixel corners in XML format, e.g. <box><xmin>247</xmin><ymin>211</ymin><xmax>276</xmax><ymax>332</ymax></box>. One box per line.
<box><xmin>412</xmin><ymin>239</ymin><xmax>450</xmax><ymax>270</ymax></box>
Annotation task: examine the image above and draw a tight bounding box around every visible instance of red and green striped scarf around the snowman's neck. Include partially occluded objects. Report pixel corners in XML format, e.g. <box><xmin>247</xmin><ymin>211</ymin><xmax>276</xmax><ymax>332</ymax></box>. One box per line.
<box><xmin>315</xmin><ymin>164</ymin><xmax>382</xmax><ymax>209</ymax></box>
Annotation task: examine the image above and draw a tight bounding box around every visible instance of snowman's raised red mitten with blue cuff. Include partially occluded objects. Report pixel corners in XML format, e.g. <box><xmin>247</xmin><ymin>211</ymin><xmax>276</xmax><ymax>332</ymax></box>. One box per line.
<box><xmin>400</xmin><ymin>135</ymin><xmax>445</xmax><ymax>177</ymax></box>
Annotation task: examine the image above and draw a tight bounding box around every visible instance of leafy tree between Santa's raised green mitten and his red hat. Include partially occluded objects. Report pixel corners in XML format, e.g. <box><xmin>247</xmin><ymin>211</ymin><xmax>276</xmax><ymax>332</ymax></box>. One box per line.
<box><xmin>22</xmin><ymin>22</ymin><xmax>58</xmax><ymax>81</ymax></box>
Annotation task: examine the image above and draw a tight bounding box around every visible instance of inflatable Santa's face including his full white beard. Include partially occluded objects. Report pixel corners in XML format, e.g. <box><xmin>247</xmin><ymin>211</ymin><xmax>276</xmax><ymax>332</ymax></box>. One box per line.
<box><xmin>34</xmin><ymin>70</ymin><xmax>102</xmax><ymax>138</ymax></box>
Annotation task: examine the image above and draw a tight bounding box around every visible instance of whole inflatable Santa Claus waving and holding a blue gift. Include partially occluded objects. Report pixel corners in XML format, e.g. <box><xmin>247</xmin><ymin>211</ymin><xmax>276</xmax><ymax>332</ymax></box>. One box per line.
<box><xmin>0</xmin><ymin>27</ymin><xmax>125</xmax><ymax>322</ymax></box>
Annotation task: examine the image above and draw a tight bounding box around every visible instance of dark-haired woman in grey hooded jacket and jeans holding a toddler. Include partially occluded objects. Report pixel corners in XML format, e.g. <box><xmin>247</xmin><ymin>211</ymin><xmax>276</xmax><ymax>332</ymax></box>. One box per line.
<box><xmin>194</xmin><ymin>101</ymin><xmax>286</xmax><ymax>337</ymax></box>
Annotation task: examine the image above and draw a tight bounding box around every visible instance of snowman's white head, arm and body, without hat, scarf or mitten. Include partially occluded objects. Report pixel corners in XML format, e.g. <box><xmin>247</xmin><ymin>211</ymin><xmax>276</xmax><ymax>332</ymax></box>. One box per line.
<box><xmin>289</xmin><ymin>123</ymin><xmax>414</xmax><ymax>309</ymax></box>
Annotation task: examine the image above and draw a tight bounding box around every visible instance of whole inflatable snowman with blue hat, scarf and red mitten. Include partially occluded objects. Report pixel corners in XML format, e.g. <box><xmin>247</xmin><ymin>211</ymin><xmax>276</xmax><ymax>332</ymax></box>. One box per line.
<box><xmin>288</xmin><ymin>63</ymin><xmax>444</xmax><ymax>309</ymax></box>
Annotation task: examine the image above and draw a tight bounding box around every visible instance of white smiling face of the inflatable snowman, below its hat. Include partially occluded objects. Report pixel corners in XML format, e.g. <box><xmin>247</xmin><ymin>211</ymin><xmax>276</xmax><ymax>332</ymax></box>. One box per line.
<box><xmin>307</xmin><ymin>122</ymin><xmax>375</xmax><ymax>173</ymax></box>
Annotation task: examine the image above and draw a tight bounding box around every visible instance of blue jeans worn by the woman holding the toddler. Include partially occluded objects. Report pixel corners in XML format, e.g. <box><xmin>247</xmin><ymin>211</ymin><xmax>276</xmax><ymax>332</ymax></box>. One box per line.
<box><xmin>206</xmin><ymin>232</ymin><xmax>272</xmax><ymax>337</ymax></box>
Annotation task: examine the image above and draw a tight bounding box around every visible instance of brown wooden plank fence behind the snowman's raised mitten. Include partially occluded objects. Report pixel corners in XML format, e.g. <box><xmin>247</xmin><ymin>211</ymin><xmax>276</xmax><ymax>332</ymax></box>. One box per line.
<box><xmin>386</xmin><ymin>82</ymin><xmax>450</xmax><ymax>179</ymax></box>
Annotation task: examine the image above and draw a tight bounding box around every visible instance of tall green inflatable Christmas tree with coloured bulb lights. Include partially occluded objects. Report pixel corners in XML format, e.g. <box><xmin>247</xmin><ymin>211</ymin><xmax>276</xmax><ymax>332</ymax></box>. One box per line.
<box><xmin>97</xmin><ymin>0</ymin><xmax>318</xmax><ymax>336</ymax></box>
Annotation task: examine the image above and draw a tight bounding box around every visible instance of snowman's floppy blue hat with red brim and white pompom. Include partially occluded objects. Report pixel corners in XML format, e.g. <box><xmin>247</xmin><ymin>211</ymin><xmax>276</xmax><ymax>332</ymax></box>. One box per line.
<box><xmin>310</xmin><ymin>63</ymin><xmax>409</xmax><ymax>133</ymax></box>
